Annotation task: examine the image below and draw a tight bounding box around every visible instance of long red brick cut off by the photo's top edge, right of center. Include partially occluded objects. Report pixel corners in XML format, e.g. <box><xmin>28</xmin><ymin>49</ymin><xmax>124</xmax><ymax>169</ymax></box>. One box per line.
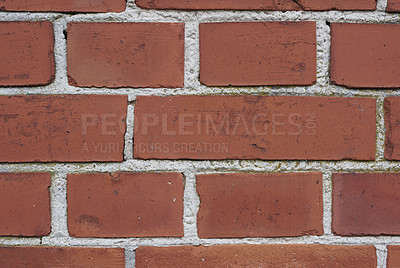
<box><xmin>136</xmin><ymin>0</ymin><xmax>376</xmax><ymax>10</ymax></box>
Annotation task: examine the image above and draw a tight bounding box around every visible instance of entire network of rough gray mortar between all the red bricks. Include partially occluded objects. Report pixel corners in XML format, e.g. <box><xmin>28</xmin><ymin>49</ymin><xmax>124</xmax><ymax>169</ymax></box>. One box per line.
<box><xmin>0</xmin><ymin>0</ymin><xmax>400</xmax><ymax>268</ymax></box>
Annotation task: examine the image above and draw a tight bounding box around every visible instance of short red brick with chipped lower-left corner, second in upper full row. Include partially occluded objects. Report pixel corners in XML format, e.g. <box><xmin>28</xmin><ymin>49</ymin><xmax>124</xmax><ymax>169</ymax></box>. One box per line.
<box><xmin>67</xmin><ymin>23</ymin><xmax>184</xmax><ymax>88</ymax></box>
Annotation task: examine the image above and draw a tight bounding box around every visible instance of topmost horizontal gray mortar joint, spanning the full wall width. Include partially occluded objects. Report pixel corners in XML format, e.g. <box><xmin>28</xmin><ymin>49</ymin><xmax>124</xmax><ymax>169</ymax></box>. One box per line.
<box><xmin>0</xmin><ymin>12</ymin><xmax>400</xmax><ymax>23</ymax></box>
